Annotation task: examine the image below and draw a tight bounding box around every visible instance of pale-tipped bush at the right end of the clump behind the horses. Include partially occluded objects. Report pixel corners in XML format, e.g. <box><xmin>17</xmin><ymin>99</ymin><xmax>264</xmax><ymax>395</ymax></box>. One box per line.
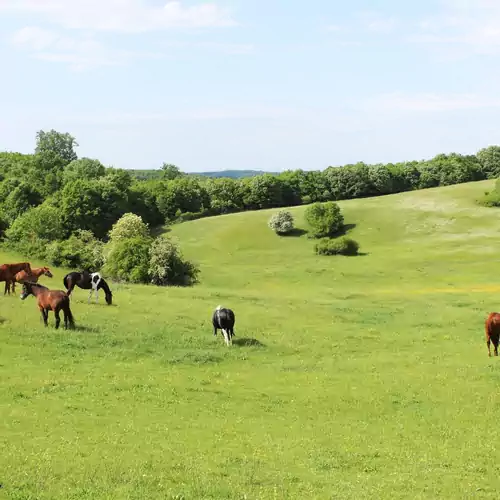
<box><xmin>149</xmin><ymin>236</ymin><xmax>199</xmax><ymax>286</ymax></box>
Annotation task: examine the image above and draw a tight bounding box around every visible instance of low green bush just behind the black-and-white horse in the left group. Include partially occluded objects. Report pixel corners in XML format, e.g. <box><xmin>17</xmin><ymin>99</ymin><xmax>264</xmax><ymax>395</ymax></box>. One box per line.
<box><xmin>46</xmin><ymin>230</ymin><xmax>104</xmax><ymax>271</ymax></box>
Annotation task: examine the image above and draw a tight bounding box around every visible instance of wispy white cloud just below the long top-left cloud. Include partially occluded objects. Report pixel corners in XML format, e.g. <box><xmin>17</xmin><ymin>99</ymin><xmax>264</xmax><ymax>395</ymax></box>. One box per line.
<box><xmin>11</xmin><ymin>26</ymin><xmax>161</xmax><ymax>71</ymax></box>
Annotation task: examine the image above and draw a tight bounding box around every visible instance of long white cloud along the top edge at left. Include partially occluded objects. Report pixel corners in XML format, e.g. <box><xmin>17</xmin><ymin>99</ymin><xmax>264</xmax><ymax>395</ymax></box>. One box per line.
<box><xmin>0</xmin><ymin>0</ymin><xmax>237</xmax><ymax>33</ymax></box>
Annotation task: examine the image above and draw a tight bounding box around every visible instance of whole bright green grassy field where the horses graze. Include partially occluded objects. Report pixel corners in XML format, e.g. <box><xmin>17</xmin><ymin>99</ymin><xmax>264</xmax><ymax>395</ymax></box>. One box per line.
<box><xmin>0</xmin><ymin>178</ymin><xmax>500</xmax><ymax>500</ymax></box>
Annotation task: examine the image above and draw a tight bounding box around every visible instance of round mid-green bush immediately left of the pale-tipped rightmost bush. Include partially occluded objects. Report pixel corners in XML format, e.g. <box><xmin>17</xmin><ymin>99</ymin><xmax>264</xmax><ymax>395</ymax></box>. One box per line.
<box><xmin>104</xmin><ymin>237</ymin><xmax>151</xmax><ymax>283</ymax></box>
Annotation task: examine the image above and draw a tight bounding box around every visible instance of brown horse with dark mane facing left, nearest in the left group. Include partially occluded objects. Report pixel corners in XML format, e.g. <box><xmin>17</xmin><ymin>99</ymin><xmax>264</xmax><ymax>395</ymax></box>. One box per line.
<box><xmin>19</xmin><ymin>281</ymin><xmax>75</xmax><ymax>329</ymax></box>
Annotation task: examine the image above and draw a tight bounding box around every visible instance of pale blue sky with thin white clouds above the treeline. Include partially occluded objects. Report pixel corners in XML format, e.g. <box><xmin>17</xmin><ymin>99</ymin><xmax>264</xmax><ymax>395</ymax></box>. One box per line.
<box><xmin>0</xmin><ymin>0</ymin><xmax>500</xmax><ymax>172</ymax></box>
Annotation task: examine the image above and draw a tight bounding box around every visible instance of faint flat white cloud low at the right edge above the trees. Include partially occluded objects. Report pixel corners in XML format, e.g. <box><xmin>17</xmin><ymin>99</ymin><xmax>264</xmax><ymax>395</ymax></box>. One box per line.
<box><xmin>364</xmin><ymin>92</ymin><xmax>500</xmax><ymax>113</ymax></box>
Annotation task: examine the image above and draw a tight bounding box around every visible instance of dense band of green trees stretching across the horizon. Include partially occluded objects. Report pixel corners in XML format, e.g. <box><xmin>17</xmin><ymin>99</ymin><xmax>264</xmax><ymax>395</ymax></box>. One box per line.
<box><xmin>0</xmin><ymin>130</ymin><xmax>500</xmax><ymax>276</ymax></box>
